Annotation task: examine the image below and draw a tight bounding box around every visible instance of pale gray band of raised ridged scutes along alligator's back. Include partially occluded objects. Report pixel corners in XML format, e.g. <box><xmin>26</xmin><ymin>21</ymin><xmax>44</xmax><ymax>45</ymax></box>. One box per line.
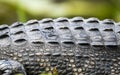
<box><xmin>0</xmin><ymin>17</ymin><xmax>120</xmax><ymax>46</ymax></box>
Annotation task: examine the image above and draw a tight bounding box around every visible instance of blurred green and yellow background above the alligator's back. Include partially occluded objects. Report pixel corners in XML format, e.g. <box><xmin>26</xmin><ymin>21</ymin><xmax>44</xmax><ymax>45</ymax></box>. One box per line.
<box><xmin>0</xmin><ymin>0</ymin><xmax>120</xmax><ymax>25</ymax></box>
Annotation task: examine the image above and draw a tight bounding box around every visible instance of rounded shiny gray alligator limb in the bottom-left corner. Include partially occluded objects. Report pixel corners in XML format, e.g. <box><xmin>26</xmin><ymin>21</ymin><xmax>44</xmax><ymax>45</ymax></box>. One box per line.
<box><xmin>0</xmin><ymin>60</ymin><xmax>26</xmax><ymax>75</ymax></box>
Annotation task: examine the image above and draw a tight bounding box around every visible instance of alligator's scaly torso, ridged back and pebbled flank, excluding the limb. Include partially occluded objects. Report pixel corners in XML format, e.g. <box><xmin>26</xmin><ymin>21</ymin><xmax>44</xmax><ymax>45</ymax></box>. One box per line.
<box><xmin>0</xmin><ymin>17</ymin><xmax>120</xmax><ymax>75</ymax></box>
